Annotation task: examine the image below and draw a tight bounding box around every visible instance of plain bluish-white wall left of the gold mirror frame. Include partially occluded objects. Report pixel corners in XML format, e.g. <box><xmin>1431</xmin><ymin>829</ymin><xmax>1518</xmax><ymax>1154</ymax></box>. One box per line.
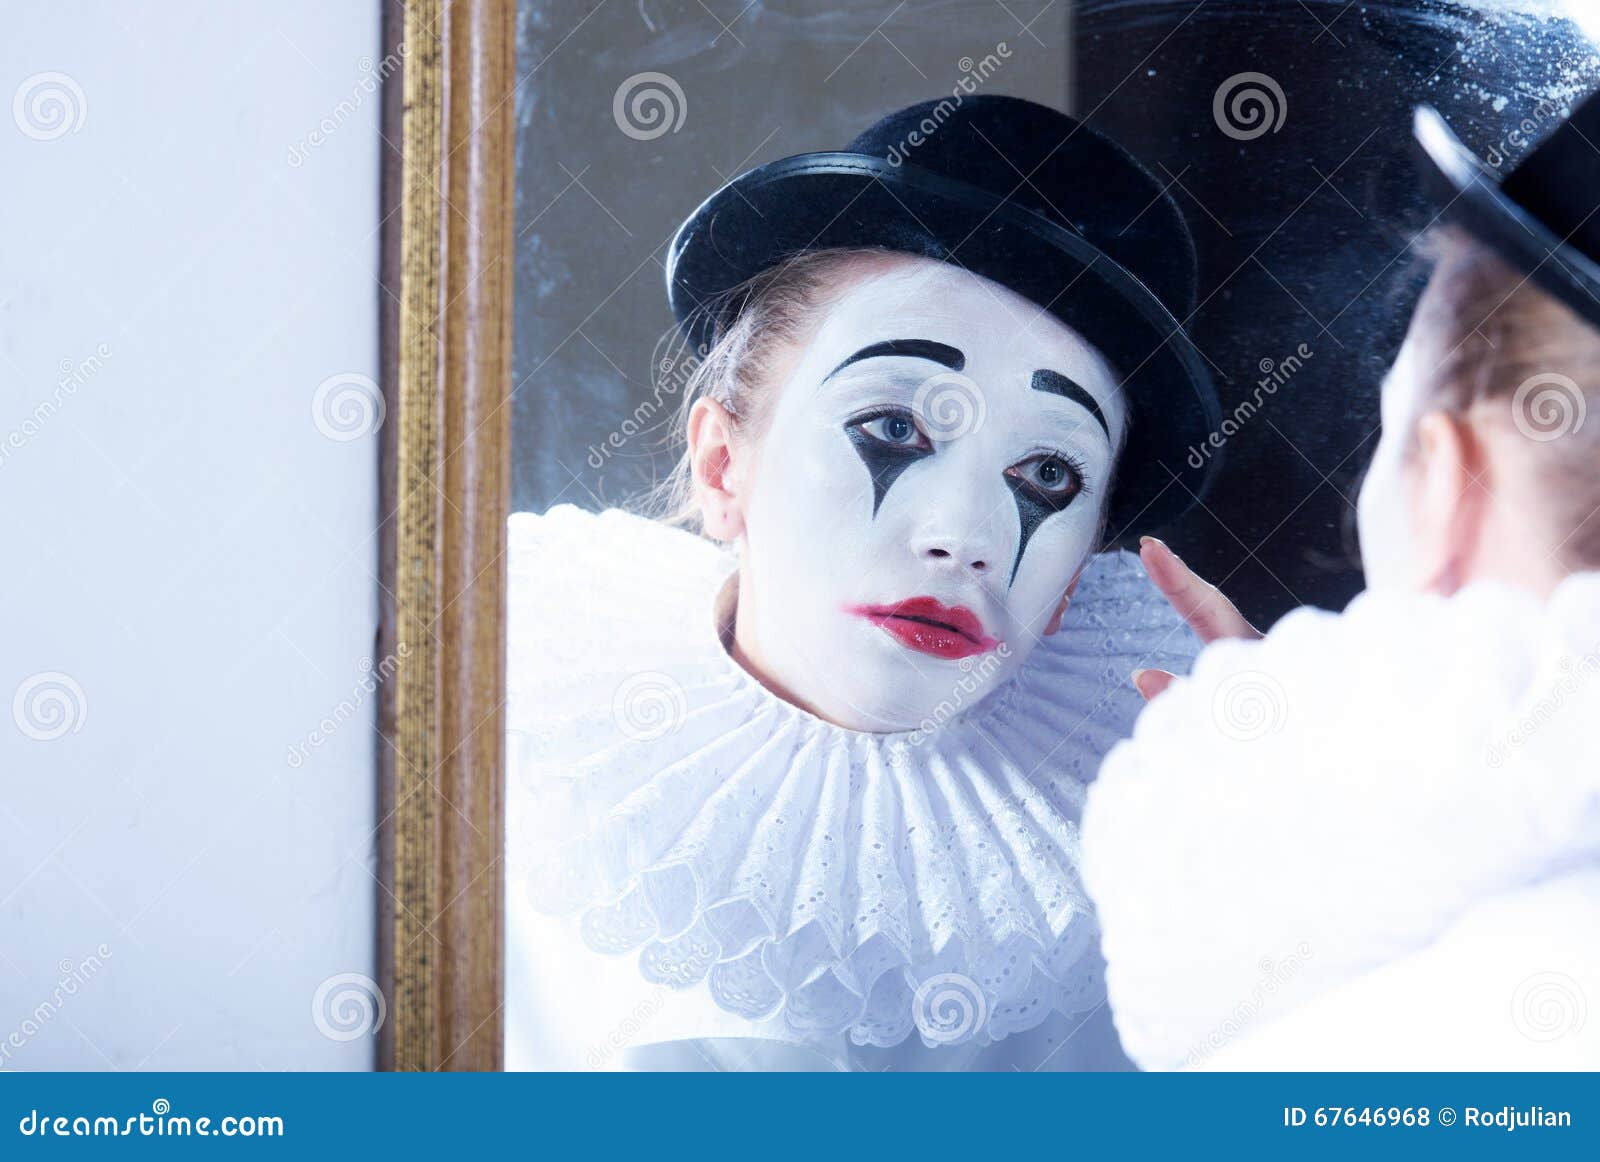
<box><xmin>0</xmin><ymin>0</ymin><xmax>379</xmax><ymax>1069</ymax></box>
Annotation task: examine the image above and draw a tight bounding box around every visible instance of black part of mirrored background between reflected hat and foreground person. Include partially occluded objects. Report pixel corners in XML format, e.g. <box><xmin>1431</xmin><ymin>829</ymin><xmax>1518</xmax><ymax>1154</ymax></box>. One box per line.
<box><xmin>1075</xmin><ymin>0</ymin><xmax>1600</xmax><ymax>626</ymax></box>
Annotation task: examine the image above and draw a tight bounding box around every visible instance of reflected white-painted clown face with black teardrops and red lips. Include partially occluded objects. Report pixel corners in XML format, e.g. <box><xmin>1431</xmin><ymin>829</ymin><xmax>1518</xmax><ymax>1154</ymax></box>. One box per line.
<box><xmin>738</xmin><ymin>258</ymin><xmax>1125</xmax><ymax>731</ymax></box>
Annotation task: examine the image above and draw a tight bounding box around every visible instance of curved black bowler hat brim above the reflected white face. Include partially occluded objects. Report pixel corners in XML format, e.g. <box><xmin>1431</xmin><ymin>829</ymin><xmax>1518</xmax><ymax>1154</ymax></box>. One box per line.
<box><xmin>667</xmin><ymin>152</ymin><xmax>1221</xmax><ymax>546</ymax></box>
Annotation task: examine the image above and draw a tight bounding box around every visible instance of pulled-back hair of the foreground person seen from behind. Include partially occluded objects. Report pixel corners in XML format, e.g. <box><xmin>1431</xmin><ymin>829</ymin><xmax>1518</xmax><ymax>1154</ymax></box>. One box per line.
<box><xmin>1411</xmin><ymin>227</ymin><xmax>1600</xmax><ymax>568</ymax></box>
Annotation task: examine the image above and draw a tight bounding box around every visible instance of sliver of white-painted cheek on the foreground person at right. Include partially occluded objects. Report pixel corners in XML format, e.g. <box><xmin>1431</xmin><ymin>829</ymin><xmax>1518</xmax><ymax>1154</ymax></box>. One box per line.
<box><xmin>1355</xmin><ymin>336</ymin><xmax>1422</xmax><ymax>589</ymax></box>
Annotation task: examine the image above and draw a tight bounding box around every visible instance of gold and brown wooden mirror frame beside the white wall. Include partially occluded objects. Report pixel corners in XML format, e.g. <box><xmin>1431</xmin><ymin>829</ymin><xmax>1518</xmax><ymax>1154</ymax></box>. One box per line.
<box><xmin>378</xmin><ymin>0</ymin><xmax>517</xmax><ymax>1069</ymax></box>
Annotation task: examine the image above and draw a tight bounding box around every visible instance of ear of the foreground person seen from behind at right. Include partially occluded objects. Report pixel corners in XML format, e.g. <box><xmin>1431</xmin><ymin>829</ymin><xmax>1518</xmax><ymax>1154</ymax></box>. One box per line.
<box><xmin>1410</xmin><ymin>411</ymin><xmax>1493</xmax><ymax>597</ymax></box>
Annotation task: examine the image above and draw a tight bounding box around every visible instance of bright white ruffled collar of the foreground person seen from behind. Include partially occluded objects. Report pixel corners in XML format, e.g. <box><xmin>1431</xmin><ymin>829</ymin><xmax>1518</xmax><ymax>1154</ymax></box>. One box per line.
<box><xmin>1083</xmin><ymin>573</ymin><xmax>1600</xmax><ymax>1068</ymax></box>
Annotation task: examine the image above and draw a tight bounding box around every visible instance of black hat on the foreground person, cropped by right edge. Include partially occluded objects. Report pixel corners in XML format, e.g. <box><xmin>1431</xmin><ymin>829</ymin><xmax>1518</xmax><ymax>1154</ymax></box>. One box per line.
<box><xmin>1413</xmin><ymin>93</ymin><xmax>1600</xmax><ymax>327</ymax></box>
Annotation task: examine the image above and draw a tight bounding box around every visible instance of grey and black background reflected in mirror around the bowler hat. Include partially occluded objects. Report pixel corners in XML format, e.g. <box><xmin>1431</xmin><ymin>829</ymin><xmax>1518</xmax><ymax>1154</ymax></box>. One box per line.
<box><xmin>512</xmin><ymin>0</ymin><xmax>1600</xmax><ymax>626</ymax></box>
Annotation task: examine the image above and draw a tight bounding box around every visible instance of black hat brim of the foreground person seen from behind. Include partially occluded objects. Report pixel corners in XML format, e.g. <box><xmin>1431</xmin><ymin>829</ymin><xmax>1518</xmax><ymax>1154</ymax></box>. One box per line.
<box><xmin>1411</xmin><ymin>106</ymin><xmax>1600</xmax><ymax>327</ymax></box>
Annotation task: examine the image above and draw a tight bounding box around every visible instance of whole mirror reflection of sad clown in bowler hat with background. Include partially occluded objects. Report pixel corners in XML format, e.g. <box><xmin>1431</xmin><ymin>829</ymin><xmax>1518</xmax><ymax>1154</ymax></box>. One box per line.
<box><xmin>506</xmin><ymin>0</ymin><xmax>1597</xmax><ymax>1069</ymax></box>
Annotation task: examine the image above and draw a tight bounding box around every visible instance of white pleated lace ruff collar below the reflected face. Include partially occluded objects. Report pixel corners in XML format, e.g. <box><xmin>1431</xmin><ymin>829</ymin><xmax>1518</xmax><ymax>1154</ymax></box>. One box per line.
<box><xmin>507</xmin><ymin>506</ymin><xmax>1197</xmax><ymax>1047</ymax></box>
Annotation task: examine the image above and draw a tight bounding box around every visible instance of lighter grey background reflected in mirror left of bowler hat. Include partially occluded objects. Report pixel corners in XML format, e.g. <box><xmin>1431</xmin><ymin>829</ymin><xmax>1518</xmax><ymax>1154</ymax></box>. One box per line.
<box><xmin>512</xmin><ymin>0</ymin><xmax>1070</xmax><ymax>511</ymax></box>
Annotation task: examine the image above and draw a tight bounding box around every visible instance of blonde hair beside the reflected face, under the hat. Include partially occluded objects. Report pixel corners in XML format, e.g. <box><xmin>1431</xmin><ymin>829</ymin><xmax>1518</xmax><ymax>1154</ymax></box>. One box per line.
<box><xmin>635</xmin><ymin>246</ymin><xmax>896</xmax><ymax>528</ymax></box>
